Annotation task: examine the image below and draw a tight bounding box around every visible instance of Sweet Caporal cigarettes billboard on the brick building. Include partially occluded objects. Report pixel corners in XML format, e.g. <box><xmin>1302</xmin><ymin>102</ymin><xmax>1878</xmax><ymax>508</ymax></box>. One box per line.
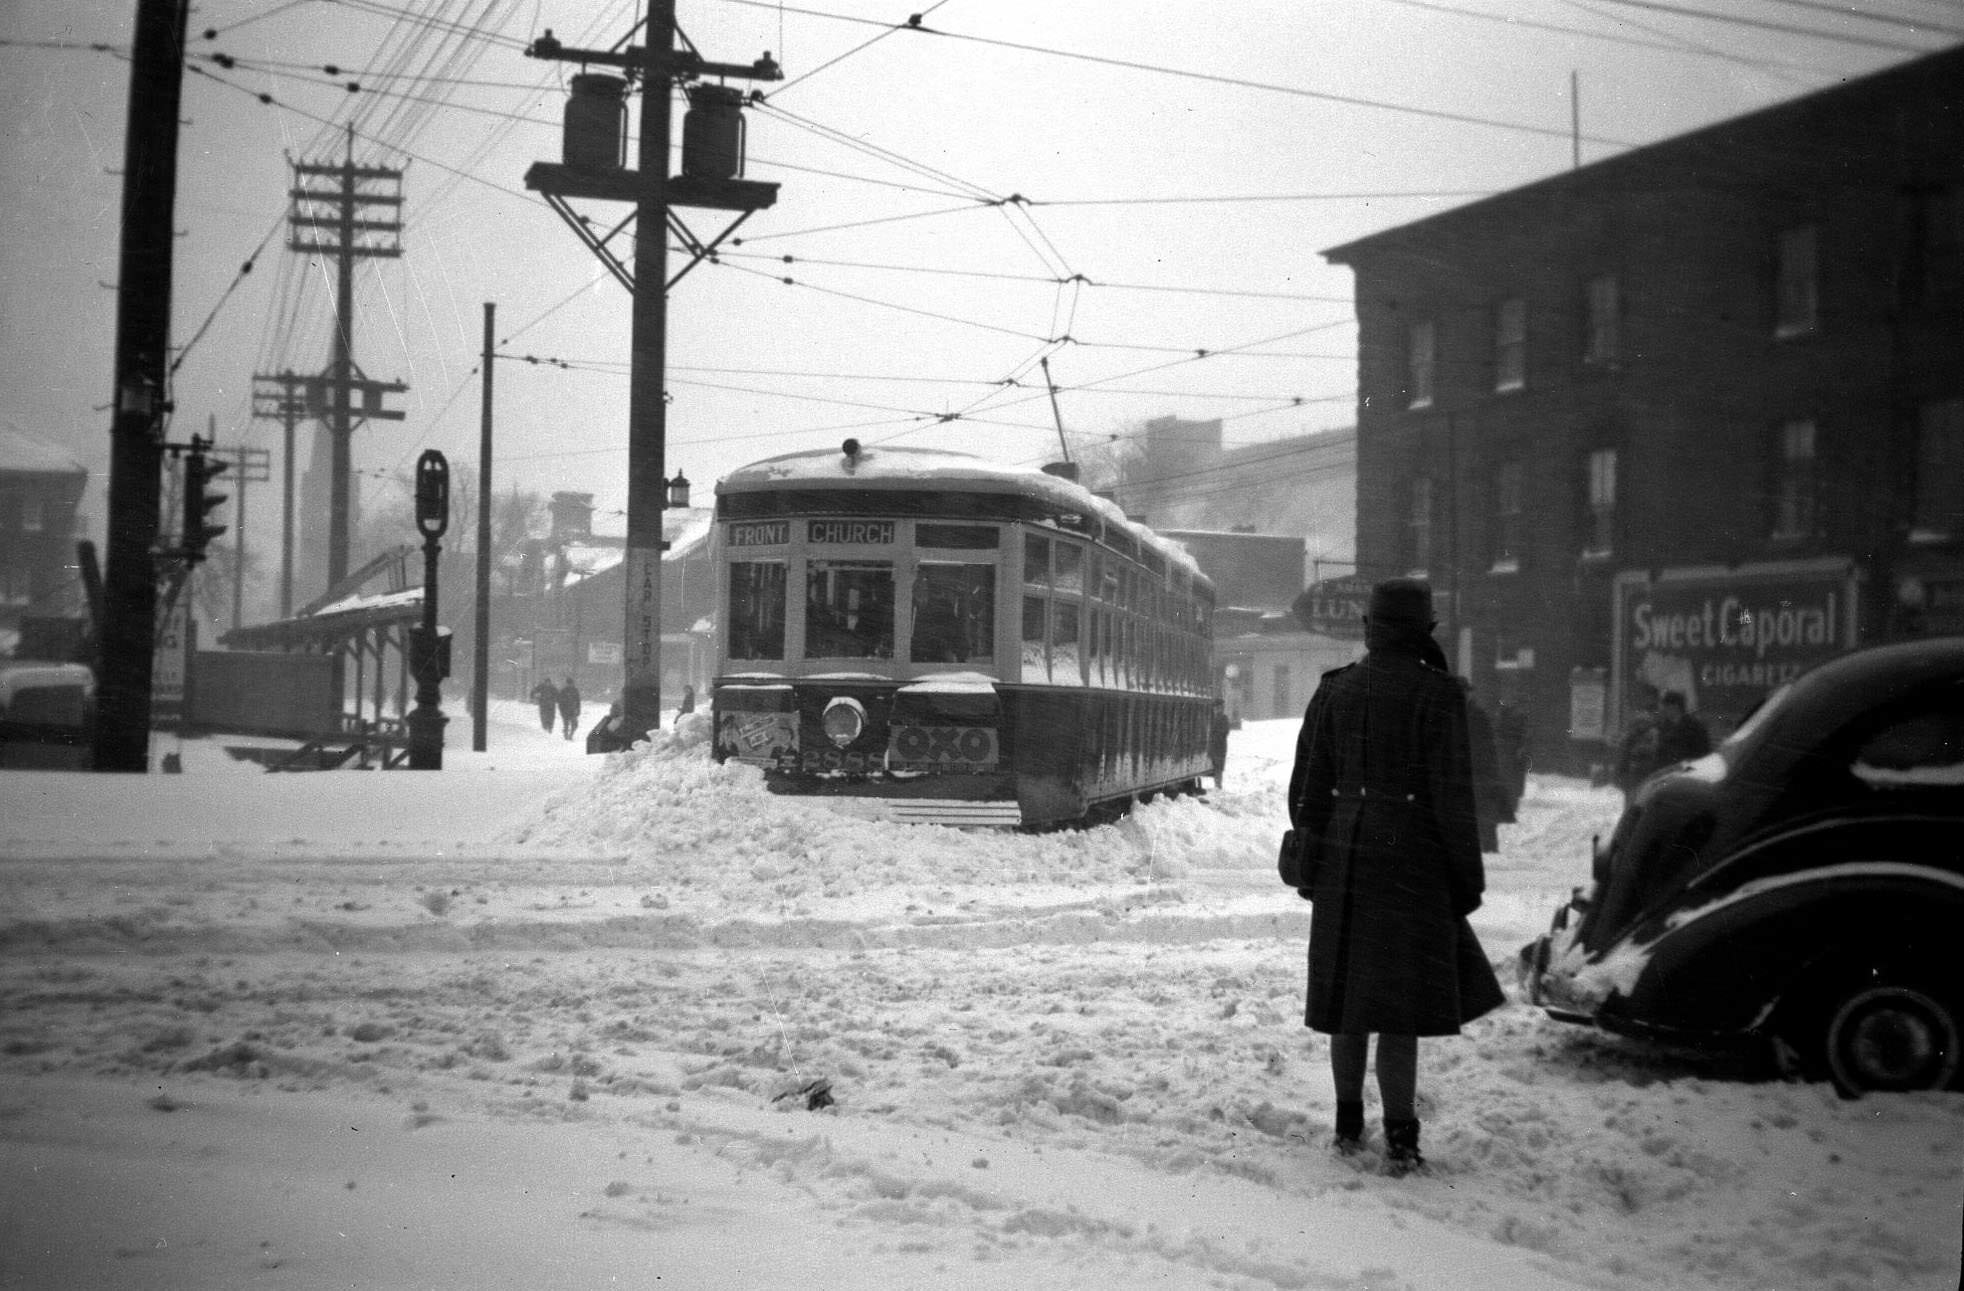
<box><xmin>1616</xmin><ymin>566</ymin><xmax>1856</xmax><ymax>735</ymax></box>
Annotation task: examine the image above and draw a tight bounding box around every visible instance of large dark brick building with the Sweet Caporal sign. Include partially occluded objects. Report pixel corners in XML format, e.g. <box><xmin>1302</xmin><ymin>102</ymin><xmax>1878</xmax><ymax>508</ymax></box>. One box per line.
<box><xmin>1326</xmin><ymin>49</ymin><xmax>1964</xmax><ymax>770</ymax></box>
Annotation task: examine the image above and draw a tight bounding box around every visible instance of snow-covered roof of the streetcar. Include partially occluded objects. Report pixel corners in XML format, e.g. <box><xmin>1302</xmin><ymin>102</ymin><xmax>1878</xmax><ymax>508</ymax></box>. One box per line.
<box><xmin>717</xmin><ymin>446</ymin><xmax>1212</xmax><ymax>588</ymax></box>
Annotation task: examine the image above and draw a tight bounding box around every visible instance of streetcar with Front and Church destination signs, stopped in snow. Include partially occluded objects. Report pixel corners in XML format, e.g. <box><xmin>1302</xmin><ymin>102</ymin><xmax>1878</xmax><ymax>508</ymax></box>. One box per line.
<box><xmin>711</xmin><ymin>440</ymin><xmax>1214</xmax><ymax>829</ymax></box>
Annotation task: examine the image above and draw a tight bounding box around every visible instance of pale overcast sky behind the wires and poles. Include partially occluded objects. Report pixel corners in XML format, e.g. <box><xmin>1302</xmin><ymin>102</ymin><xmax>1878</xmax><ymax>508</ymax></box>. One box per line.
<box><xmin>0</xmin><ymin>0</ymin><xmax>1964</xmax><ymax>589</ymax></box>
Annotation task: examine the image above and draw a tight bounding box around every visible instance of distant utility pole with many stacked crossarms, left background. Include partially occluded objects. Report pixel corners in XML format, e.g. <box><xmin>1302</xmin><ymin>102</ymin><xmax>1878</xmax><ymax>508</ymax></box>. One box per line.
<box><xmin>287</xmin><ymin>126</ymin><xmax>409</xmax><ymax>588</ymax></box>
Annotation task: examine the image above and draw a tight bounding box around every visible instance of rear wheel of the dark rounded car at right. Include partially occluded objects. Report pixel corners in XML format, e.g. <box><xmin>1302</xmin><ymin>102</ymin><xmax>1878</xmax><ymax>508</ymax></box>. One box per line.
<box><xmin>1823</xmin><ymin>981</ymin><xmax>1960</xmax><ymax>1096</ymax></box>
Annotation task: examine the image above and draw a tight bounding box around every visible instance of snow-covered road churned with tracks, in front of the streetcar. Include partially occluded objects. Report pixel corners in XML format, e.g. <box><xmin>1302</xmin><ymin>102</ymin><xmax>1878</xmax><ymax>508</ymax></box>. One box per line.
<box><xmin>0</xmin><ymin>721</ymin><xmax>1964</xmax><ymax>1289</ymax></box>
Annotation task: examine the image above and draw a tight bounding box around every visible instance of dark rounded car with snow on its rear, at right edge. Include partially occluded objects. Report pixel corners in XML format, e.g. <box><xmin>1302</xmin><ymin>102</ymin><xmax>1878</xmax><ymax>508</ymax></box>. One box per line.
<box><xmin>1520</xmin><ymin>637</ymin><xmax>1964</xmax><ymax>1095</ymax></box>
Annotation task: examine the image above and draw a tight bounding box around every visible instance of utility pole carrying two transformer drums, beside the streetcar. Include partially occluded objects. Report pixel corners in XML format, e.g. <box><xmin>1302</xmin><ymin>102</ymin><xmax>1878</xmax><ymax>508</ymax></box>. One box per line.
<box><xmin>524</xmin><ymin>10</ymin><xmax>784</xmax><ymax>741</ymax></box>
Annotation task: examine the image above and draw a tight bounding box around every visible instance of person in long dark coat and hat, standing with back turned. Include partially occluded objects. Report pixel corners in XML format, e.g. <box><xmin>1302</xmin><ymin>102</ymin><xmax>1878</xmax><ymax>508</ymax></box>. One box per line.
<box><xmin>1288</xmin><ymin>578</ymin><xmax>1504</xmax><ymax>1173</ymax></box>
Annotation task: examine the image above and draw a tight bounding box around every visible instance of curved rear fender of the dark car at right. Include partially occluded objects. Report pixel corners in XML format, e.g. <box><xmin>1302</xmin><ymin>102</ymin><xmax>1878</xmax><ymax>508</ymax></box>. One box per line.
<box><xmin>1605</xmin><ymin>861</ymin><xmax>1964</xmax><ymax>1036</ymax></box>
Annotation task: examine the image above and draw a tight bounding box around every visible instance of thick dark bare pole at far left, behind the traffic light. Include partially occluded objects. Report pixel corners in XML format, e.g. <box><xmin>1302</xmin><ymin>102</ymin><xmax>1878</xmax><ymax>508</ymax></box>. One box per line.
<box><xmin>90</xmin><ymin>0</ymin><xmax>189</xmax><ymax>772</ymax></box>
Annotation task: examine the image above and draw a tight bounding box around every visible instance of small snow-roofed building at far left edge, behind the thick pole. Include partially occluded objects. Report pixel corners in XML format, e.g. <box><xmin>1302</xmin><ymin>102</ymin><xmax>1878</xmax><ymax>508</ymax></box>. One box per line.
<box><xmin>0</xmin><ymin>426</ymin><xmax>88</xmax><ymax>654</ymax></box>
